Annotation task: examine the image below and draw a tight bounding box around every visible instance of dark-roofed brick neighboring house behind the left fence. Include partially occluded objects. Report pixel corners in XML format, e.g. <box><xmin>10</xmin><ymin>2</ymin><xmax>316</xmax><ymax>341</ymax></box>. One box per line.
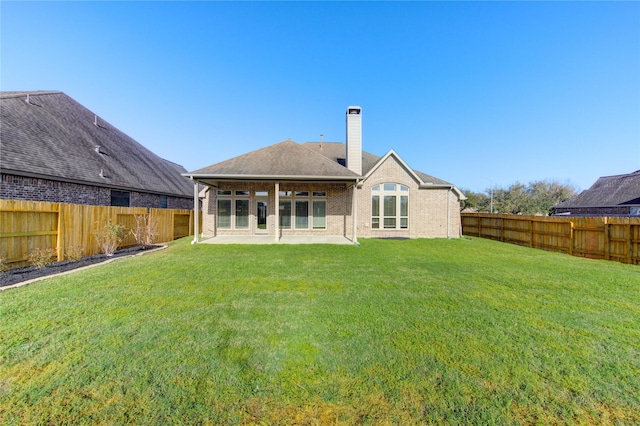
<box><xmin>0</xmin><ymin>92</ymin><xmax>194</xmax><ymax>209</ymax></box>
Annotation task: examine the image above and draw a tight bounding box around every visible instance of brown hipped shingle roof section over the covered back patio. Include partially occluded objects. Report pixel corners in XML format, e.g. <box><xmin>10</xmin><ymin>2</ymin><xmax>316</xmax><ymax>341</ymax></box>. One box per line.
<box><xmin>187</xmin><ymin>140</ymin><xmax>359</xmax><ymax>180</ymax></box>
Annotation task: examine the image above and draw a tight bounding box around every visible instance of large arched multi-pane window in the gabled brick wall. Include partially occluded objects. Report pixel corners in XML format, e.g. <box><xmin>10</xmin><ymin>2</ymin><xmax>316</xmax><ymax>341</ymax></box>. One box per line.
<box><xmin>371</xmin><ymin>183</ymin><xmax>409</xmax><ymax>229</ymax></box>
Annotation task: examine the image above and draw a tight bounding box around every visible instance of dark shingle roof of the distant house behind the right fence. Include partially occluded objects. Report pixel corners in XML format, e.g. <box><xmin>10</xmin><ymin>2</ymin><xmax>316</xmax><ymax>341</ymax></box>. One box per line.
<box><xmin>558</xmin><ymin>170</ymin><xmax>640</xmax><ymax>208</ymax></box>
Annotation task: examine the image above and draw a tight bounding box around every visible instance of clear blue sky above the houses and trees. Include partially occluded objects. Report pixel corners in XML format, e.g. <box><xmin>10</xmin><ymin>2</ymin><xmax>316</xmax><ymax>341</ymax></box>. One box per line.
<box><xmin>0</xmin><ymin>0</ymin><xmax>640</xmax><ymax>192</ymax></box>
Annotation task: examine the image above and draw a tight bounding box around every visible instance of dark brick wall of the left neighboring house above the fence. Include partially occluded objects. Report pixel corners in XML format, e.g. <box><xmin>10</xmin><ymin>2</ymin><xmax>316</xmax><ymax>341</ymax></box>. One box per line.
<box><xmin>0</xmin><ymin>174</ymin><xmax>193</xmax><ymax>210</ymax></box>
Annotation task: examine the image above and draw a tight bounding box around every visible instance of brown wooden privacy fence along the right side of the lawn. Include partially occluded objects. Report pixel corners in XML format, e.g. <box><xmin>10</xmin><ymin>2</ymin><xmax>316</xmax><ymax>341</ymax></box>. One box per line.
<box><xmin>461</xmin><ymin>213</ymin><xmax>640</xmax><ymax>265</ymax></box>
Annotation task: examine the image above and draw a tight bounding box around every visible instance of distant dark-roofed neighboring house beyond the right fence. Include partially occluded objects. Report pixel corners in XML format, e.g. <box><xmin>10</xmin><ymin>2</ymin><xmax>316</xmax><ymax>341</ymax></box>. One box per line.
<box><xmin>554</xmin><ymin>170</ymin><xmax>640</xmax><ymax>216</ymax></box>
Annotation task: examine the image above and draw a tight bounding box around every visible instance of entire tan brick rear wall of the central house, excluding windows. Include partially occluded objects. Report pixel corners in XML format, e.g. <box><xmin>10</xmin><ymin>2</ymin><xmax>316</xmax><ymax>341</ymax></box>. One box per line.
<box><xmin>202</xmin><ymin>156</ymin><xmax>462</xmax><ymax>239</ymax></box>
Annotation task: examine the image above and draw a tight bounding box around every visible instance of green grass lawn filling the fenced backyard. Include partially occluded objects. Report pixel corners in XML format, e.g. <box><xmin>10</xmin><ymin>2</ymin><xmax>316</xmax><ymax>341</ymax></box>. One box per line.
<box><xmin>0</xmin><ymin>239</ymin><xmax>640</xmax><ymax>425</ymax></box>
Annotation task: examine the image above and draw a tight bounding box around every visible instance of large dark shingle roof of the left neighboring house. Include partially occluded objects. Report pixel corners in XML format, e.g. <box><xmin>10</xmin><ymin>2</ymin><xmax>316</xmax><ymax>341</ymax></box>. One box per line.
<box><xmin>0</xmin><ymin>92</ymin><xmax>193</xmax><ymax>197</ymax></box>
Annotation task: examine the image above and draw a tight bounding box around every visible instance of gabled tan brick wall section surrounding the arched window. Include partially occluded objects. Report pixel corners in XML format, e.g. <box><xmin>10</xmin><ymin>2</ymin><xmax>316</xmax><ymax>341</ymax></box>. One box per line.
<box><xmin>357</xmin><ymin>156</ymin><xmax>461</xmax><ymax>238</ymax></box>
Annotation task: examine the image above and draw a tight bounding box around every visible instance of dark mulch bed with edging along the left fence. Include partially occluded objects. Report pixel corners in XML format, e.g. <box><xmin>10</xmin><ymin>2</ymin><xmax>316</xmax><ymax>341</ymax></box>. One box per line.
<box><xmin>0</xmin><ymin>245</ymin><xmax>162</xmax><ymax>287</ymax></box>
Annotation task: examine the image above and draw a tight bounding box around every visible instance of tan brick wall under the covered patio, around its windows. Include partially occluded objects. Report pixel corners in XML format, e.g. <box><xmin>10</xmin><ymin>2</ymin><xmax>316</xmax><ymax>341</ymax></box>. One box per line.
<box><xmin>202</xmin><ymin>181</ymin><xmax>353</xmax><ymax>238</ymax></box>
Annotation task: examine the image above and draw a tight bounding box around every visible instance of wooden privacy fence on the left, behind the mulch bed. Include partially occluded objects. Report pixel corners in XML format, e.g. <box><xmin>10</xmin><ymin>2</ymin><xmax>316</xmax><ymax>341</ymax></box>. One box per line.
<box><xmin>0</xmin><ymin>200</ymin><xmax>193</xmax><ymax>267</ymax></box>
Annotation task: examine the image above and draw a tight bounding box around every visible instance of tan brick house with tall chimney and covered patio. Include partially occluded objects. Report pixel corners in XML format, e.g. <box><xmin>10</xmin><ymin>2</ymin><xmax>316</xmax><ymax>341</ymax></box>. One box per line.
<box><xmin>185</xmin><ymin>107</ymin><xmax>464</xmax><ymax>242</ymax></box>
